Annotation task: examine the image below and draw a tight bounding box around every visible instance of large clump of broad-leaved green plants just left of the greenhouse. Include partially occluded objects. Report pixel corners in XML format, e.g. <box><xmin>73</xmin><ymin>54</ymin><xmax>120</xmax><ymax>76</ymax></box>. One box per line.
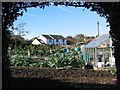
<box><xmin>49</xmin><ymin>53</ymin><xmax>84</xmax><ymax>68</ymax></box>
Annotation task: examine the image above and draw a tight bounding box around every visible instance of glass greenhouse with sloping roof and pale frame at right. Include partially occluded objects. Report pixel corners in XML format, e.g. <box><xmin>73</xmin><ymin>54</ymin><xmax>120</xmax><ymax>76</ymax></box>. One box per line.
<box><xmin>85</xmin><ymin>34</ymin><xmax>115</xmax><ymax>67</ymax></box>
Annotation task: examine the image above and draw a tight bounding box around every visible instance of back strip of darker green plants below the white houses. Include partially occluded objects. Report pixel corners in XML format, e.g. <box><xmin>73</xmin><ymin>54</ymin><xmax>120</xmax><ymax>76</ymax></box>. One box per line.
<box><xmin>8</xmin><ymin>45</ymin><xmax>54</xmax><ymax>56</ymax></box>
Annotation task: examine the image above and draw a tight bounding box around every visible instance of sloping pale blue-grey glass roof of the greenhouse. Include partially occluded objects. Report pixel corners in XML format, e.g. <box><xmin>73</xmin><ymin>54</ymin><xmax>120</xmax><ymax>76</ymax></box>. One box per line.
<box><xmin>85</xmin><ymin>34</ymin><xmax>110</xmax><ymax>48</ymax></box>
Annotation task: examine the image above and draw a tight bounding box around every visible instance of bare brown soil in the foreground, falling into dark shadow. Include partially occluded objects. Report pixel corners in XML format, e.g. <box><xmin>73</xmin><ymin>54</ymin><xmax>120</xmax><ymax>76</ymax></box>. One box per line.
<box><xmin>5</xmin><ymin>67</ymin><xmax>120</xmax><ymax>90</ymax></box>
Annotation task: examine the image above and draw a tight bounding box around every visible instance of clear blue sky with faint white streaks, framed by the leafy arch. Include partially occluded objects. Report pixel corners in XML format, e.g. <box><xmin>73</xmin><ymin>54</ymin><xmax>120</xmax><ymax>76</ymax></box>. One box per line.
<box><xmin>14</xmin><ymin>5</ymin><xmax>110</xmax><ymax>39</ymax></box>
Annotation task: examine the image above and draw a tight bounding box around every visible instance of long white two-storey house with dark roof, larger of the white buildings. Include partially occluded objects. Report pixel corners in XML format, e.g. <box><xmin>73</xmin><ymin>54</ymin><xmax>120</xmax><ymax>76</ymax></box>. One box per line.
<box><xmin>38</xmin><ymin>34</ymin><xmax>67</xmax><ymax>45</ymax></box>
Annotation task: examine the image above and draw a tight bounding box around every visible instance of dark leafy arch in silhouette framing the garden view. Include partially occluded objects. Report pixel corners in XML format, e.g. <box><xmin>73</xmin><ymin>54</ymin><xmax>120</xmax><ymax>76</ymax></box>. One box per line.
<box><xmin>2</xmin><ymin>2</ymin><xmax>120</xmax><ymax>86</ymax></box>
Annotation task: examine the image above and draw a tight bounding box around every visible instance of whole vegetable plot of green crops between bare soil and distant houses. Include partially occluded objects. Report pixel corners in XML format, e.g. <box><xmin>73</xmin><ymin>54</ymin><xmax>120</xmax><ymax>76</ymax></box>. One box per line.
<box><xmin>9</xmin><ymin>45</ymin><xmax>84</xmax><ymax>68</ymax></box>
